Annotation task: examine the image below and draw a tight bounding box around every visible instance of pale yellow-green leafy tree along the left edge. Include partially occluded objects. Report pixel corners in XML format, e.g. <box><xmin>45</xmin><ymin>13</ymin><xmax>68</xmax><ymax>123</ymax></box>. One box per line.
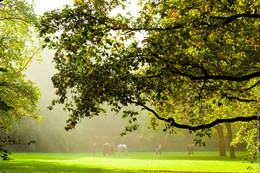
<box><xmin>0</xmin><ymin>0</ymin><xmax>40</xmax><ymax>160</ymax></box>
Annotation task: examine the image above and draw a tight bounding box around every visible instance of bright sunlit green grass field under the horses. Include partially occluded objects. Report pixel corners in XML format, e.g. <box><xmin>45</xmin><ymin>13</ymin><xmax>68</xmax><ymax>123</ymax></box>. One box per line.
<box><xmin>0</xmin><ymin>152</ymin><xmax>257</xmax><ymax>173</ymax></box>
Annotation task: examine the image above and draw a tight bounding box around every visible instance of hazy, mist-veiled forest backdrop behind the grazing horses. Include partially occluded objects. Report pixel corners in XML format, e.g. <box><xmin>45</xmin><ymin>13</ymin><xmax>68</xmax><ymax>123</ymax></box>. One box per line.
<box><xmin>4</xmin><ymin>50</ymin><xmax>245</xmax><ymax>152</ymax></box>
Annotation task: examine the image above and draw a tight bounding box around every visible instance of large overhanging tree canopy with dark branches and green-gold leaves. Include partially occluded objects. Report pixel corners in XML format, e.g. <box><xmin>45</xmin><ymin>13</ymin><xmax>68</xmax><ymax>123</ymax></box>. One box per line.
<box><xmin>39</xmin><ymin>0</ymin><xmax>260</xmax><ymax>135</ymax></box>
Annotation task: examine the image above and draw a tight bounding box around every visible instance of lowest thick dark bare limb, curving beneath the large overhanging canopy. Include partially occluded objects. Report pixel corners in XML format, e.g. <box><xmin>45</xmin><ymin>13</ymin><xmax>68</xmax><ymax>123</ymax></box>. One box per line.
<box><xmin>127</xmin><ymin>99</ymin><xmax>257</xmax><ymax>131</ymax></box>
